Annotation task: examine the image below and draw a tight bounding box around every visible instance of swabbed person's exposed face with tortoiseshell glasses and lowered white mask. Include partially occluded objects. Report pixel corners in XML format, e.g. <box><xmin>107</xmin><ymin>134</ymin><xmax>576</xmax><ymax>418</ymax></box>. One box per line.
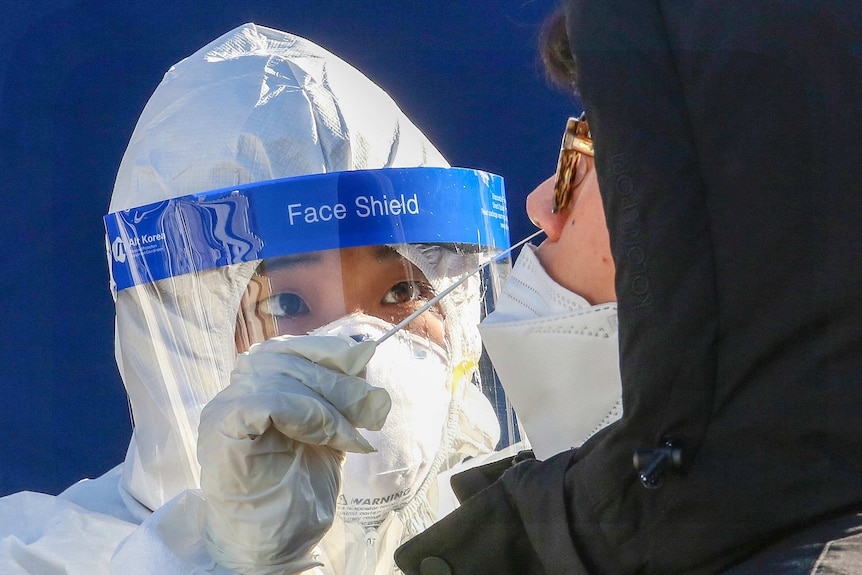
<box><xmin>480</xmin><ymin>116</ymin><xmax>622</xmax><ymax>459</ymax></box>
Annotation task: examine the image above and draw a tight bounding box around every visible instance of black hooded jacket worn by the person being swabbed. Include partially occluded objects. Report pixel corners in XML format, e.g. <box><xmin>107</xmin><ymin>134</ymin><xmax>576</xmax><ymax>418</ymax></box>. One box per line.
<box><xmin>396</xmin><ymin>0</ymin><xmax>862</xmax><ymax>575</ymax></box>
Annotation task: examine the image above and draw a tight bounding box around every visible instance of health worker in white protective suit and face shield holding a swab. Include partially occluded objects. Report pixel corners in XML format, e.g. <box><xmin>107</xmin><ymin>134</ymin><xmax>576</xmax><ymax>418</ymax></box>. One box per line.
<box><xmin>0</xmin><ymin>24</ymin><xmax>509</xmax><ymax>575</ymax></box>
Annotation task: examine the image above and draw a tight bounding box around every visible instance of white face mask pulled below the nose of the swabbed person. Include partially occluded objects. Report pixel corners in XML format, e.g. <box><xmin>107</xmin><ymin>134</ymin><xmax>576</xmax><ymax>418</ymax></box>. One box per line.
<box><xmin>479</xmin><ymin>245</ymin><xmax>622</xmax><ymax>459</ymax></box>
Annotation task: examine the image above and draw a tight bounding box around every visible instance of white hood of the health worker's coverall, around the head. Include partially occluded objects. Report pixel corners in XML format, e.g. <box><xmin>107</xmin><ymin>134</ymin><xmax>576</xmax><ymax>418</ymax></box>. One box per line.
<box><xmin>109</xmin><ymin>24</ymin><xmax>470</xmax><ymax>509</ymax></box>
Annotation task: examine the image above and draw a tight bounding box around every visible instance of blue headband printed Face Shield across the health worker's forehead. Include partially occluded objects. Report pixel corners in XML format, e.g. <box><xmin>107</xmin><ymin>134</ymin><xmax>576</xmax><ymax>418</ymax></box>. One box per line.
<box><xmin>105</xmin><ymin>168</ymin><xmax>509</xmax><ymax>291</ymax></box>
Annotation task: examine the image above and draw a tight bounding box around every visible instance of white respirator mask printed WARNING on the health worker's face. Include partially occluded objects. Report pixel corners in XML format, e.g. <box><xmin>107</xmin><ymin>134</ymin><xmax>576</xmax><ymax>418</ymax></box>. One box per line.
<box><xmin>312</xmin><ymin>314</ymin><xmax>452</xmax><ymax>527</ymax></box>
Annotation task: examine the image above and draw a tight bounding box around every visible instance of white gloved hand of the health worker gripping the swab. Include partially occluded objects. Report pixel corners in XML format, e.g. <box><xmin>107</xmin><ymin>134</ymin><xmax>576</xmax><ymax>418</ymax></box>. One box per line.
<box><xmin>198</xmin><ymin>336</ymin><xmax>391</xmax><ymax>575</ymax></box>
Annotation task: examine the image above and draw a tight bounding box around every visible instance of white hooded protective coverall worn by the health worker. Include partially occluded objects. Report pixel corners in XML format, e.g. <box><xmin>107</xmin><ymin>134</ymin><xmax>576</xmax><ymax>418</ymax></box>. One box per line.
<box><xmin>0</xmin><ymin>24</ymin><xmax>499</xmax><ymax>575</ymax></box>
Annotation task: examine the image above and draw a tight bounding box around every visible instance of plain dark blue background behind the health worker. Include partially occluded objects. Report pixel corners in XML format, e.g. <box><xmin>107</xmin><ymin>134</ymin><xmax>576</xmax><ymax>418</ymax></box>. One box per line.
<box><xmin>0</xmin><ymin>0</ymin><xmax>579</xmax><ymax>495</ymax></box>
